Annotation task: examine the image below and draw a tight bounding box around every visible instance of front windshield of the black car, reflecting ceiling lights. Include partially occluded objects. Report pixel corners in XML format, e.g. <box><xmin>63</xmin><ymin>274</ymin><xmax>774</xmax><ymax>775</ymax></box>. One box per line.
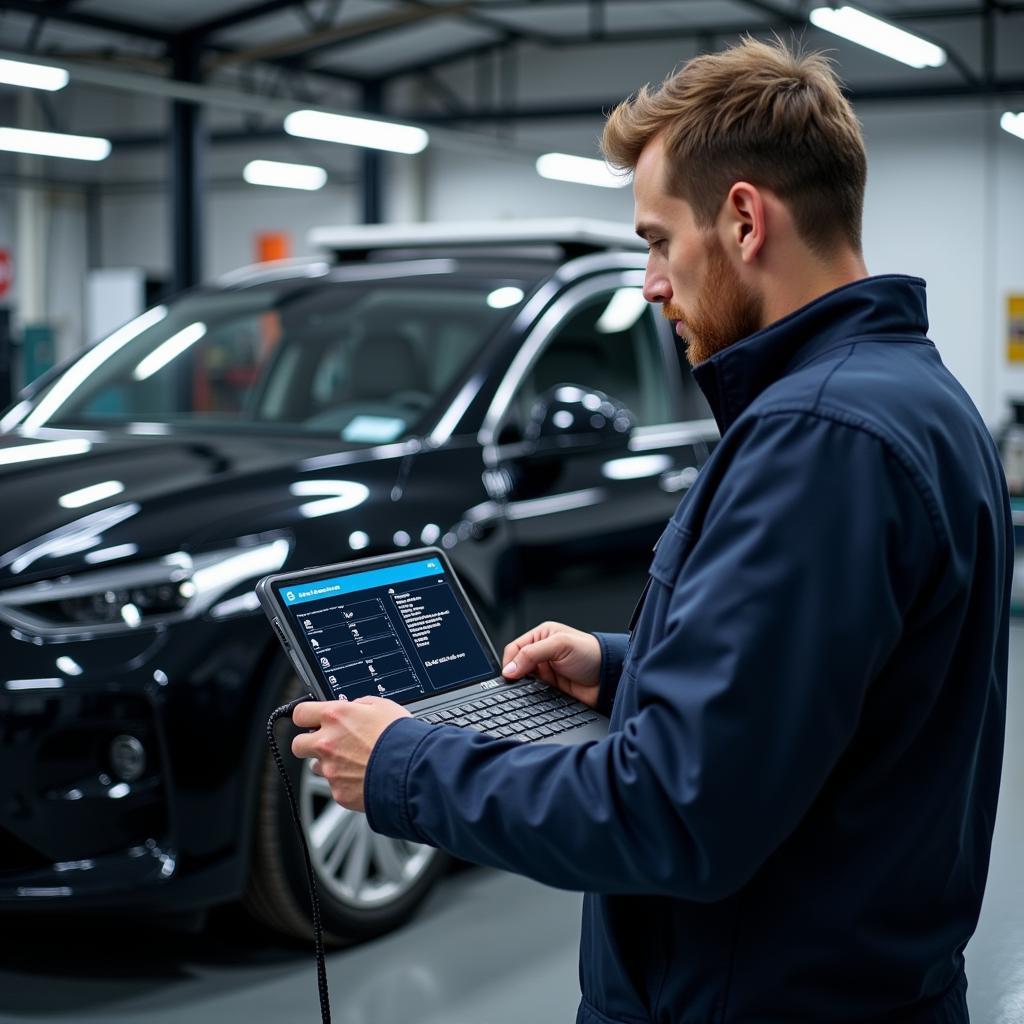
<box><xmin>22</xmin><ymin>274</ymin><xmax>527</xmax><ymax>443</ymax></box>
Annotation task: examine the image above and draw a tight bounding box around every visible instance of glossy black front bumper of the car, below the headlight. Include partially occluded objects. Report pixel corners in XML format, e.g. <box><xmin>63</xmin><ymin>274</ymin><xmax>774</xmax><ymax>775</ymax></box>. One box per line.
<box><xmin>0</xmin><ymin>618</ymin><xmax>276</xmax><ymax>910</ymax></box>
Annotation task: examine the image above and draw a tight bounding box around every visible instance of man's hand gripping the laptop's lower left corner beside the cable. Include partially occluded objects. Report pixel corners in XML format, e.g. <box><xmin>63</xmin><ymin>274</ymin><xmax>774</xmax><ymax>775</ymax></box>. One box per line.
<box><xmin>292</xmin><ymin>697</ymin><xmax>411</xmax><ymax>811</ymax></box>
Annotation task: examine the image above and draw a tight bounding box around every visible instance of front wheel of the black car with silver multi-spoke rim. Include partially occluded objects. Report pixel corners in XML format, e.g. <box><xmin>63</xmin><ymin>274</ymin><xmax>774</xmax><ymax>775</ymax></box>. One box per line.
<box><xmin>242</xmin><ymin>676</ymin><xmax>451</xmax><ymax>945</ymax></box>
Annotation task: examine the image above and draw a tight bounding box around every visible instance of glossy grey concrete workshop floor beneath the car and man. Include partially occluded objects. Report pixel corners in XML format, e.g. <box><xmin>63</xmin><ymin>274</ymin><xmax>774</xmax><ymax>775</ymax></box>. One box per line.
<box><xmin>0</xmin><ymin>625</ymin><xmax>1024</xmax><ymax>1024</ymax></box>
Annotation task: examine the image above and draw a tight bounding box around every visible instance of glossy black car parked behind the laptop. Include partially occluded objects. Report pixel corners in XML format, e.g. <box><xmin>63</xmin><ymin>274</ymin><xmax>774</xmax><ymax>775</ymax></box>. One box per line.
<box><xmin>0</xmin><ymin>223</ymin><xmax>717</xmax><ymax>940</ymax></box>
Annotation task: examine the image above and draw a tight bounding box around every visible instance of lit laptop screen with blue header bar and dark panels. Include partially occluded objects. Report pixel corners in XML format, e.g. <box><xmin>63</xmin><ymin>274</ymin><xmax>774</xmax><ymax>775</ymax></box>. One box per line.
<box><xmin>274</xmin><ymin>554</ymin><xmax>498</xmax><ymax>703</ymax></box>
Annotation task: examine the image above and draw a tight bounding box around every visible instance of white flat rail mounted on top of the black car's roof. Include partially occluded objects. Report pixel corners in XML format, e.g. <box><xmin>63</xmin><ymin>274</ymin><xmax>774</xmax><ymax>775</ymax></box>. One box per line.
<box><xmin>308</xmin><ymin>217</ymin><xmax>646</xmax><ymax>260</ymax></box>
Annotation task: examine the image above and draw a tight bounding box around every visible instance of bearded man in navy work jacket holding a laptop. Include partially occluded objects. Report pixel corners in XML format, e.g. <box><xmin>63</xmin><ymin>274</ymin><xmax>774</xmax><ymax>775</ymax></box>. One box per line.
<box><xmin>294</xmin><ymin>40</ymin><xmax>1013</xmax><ymax>1024</ymax></box>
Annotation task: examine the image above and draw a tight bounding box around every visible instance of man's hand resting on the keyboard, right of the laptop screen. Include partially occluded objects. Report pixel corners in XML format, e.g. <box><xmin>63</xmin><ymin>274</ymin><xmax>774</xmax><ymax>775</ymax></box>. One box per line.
<box><xmin>502</xmin><ymin>623</ymin><xmax>601</xmax><ymax>708</ymax></box>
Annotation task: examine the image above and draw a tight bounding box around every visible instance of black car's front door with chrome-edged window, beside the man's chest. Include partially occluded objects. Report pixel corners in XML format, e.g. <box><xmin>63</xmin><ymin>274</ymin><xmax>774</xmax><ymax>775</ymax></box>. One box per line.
<box><xmin>489</xmin><ymin>270</ymin><xmax>717</xmax><ymax>630</ymax></box>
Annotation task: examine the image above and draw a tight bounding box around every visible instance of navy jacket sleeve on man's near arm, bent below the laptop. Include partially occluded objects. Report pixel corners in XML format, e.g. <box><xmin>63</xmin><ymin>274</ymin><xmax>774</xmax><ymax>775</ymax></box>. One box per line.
<box><xmin>366</xmin><ymin>414</ymin><xmax>939</xmax><ymax>900</ymax></box>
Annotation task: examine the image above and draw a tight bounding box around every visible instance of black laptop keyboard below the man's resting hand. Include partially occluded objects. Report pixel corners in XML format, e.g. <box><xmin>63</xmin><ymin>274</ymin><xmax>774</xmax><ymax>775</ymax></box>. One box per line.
<box><xmin>416</xmin><ymin>680</ymin><xmax>599</xmax><ymax>742</ymax></box>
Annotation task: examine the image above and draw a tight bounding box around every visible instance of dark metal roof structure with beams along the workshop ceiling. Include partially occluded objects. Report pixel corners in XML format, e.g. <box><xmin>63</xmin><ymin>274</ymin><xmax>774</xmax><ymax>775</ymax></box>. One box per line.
<box><xmin>0</xmin><ymin>0</ymin><xmax>1024</xmax><ymax>125</ymax></box>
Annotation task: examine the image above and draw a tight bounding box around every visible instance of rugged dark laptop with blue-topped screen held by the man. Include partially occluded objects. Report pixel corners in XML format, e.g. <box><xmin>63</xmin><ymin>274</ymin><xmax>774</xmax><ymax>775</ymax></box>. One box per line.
<box><xmin>256</xmin><ymin>548</ymin><xmax>608</xmax><ymax>743</ymax></box>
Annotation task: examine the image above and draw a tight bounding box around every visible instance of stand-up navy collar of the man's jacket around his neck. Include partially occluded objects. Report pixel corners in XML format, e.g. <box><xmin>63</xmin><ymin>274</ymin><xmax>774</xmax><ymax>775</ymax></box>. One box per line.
<box><xmin>693</xmin><ymin>274</ymin><xmax>928</xmax><ymax>434</ymax></box>
